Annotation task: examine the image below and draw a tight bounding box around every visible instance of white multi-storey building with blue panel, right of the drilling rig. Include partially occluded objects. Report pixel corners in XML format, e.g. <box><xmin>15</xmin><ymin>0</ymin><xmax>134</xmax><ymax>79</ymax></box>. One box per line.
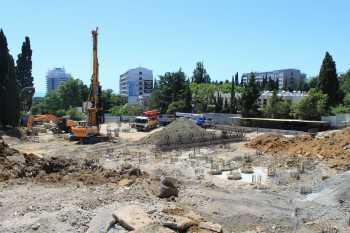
<box><xmin>119</xmin><ymin>67</ymin><xmax>153</xmax><ymax>104</ymax></box>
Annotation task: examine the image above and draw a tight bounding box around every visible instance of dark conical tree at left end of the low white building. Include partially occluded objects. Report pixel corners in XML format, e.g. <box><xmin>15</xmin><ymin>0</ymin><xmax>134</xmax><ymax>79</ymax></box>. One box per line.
<box><xmin>241</xmin><ymin>73</ymin><xmax>260</xmax><ymax>116</ymax></box>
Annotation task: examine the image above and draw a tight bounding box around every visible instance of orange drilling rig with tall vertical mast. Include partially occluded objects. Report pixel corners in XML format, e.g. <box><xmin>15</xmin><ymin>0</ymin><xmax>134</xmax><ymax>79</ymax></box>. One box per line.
<box><xmin>69</xmin><ymin>28</ymin><xmax>108</xmax><ymax>144</ymax></box>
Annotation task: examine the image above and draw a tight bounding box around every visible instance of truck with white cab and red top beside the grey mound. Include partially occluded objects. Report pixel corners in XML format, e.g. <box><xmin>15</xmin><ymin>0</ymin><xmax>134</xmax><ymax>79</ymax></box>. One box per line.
<box><xmin>132</xmin><ymin>110</ymin><xmax>160</xmax><ymax>131</ymax></box>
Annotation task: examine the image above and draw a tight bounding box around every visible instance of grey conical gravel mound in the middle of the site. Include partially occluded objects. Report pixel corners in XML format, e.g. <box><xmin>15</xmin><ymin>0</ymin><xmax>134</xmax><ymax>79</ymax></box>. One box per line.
<box><xmin>143</xmin><ymin>118</ymin><xmax>212</xmax><ymax>145</ymax></box>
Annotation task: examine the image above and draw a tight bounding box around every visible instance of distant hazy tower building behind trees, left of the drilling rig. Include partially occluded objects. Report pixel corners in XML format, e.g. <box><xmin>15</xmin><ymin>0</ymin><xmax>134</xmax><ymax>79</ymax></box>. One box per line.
<box><xmin>46</xmin><ymin>68</ymin><xmax>72</xmax><ymax>93</ymax></box>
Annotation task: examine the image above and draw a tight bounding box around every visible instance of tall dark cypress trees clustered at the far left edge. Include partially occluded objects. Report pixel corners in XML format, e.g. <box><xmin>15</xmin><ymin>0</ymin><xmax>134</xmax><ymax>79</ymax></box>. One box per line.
<box><xmin>0</xmin><ymin>29</ymin><xmax>34</xmax><ymax>126</ymax></box>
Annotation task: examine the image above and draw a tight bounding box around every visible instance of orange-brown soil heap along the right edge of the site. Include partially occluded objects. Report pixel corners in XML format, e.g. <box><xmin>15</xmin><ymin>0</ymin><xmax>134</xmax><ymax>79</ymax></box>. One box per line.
<box><xmin>247</xmin><ymin>128</ymin><xmax>350</xmax><ymax>169</ymax></box>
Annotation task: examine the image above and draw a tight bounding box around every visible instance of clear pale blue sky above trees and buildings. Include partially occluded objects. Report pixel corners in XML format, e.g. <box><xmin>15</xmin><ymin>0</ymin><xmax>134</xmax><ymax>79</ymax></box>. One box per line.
<box><xmin>0</xmin><ymin>0</ymin><xmax>350</xmax><ymax>95</ymax></box>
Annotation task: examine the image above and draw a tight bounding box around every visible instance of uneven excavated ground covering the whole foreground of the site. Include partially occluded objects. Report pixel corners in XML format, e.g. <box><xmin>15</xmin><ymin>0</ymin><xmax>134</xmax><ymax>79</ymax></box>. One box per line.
<box><xmin>0</xmin><ymin>125</ymin><xmax>350</xmax><ymax>233</ymax></box>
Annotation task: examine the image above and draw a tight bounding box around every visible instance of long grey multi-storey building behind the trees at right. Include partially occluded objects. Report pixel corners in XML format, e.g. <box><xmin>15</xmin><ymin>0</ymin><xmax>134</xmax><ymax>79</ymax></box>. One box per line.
<box><xmin>242</xmin><ymin>69</ymin><xmax>306</xmax><ymax>90</ymax></box>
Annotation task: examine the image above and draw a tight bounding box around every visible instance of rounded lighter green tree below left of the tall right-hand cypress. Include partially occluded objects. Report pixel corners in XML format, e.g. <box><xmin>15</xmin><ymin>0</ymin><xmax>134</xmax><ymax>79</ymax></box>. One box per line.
<box><xmin>294</xmin><ymin>89</ymin><xmax>328</xmax><ymax>120</ymax></box>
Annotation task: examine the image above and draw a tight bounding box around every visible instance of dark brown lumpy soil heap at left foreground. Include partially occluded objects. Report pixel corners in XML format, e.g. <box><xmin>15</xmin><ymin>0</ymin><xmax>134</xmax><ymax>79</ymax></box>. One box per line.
<box><xmin>0</xmin><ymin>137</ymin><xmax>139</xmax><ymax>185</ymax></box>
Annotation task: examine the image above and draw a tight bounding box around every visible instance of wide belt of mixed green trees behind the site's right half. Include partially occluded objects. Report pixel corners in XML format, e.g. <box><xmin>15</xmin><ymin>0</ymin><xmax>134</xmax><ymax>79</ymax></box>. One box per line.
<box><xmin>149</xmin><ymin>52</ymin><xmax>350</xmax><ymax>120</ymax></box>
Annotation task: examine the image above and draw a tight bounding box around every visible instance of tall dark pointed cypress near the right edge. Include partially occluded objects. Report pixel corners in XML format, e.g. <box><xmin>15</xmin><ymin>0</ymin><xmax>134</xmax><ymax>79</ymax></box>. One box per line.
<box><xmin>318</xmin><ymin>52</ymin><xmax>339</xmax><ymax>106</ymax></box>
